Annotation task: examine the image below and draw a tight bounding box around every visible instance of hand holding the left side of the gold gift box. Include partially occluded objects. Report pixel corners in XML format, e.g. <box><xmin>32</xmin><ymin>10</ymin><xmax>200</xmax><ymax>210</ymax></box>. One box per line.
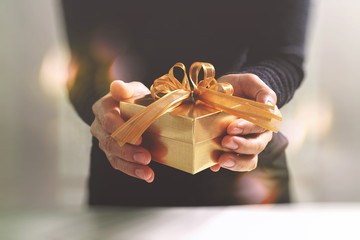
<box><xmin>90</xmin><ymin>80</ymin><xmax>154</xmax><ymax>183</ymax></box>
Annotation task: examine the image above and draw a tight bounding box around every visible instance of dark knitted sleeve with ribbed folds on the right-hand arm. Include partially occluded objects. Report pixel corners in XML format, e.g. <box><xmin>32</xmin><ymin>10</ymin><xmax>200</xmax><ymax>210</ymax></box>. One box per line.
<box><xmin>239</xmin><ymin>0</ymin><xmax>309</xmax><ymax>107</ymax></box>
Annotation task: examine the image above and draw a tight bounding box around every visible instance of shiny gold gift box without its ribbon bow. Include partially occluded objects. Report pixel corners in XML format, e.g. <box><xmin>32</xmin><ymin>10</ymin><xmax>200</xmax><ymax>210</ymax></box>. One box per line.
<box><xmin>120</xmin><ymin>95</ymin><xmax>236</xmax><ymax>174</ymax></box>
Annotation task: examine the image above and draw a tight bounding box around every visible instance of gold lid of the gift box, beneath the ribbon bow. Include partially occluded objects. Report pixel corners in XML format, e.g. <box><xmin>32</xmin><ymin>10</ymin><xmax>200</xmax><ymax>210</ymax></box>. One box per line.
<box><xmin>120</xmin><ymin>95</ymin><xmax>236</xmax><ymax>143</ymax></box>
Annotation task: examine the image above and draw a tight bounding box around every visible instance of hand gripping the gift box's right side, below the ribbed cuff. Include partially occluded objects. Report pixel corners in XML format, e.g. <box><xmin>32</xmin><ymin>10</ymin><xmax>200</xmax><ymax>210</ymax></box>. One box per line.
<box><xmin>211</xmin><ymin>74</ymin><xmax>278</xmax><ymax>172</ymax></box>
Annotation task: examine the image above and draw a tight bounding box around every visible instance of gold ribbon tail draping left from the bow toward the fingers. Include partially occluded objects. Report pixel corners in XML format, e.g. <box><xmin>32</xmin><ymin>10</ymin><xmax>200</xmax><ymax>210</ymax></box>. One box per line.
<box><xmin>111</xmin><ymin>89</ymin><xmax>190</xmax><ymax>146</ymax></box>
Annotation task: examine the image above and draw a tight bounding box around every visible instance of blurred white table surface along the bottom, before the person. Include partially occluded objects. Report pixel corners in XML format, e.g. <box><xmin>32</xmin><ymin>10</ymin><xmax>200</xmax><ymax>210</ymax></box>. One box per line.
<box><xmin>0</xmin><ymin>203</ymin><xmax>360</xmax><ymax>240</ymax></box>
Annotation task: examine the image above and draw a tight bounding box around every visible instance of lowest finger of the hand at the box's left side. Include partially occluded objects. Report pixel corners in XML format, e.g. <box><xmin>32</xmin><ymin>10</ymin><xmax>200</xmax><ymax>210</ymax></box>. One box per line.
<box><xmin>107</xmin><ymin>155</ymin><xmax>155</xmax><ymax>183</ymax></box>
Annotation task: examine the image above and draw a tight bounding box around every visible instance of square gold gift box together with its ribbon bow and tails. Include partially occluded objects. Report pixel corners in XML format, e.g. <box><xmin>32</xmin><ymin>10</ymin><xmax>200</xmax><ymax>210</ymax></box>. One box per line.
<box><xmin>111</xmin><ymin>62</ymin><xmax>282</xmax><ymax>174</ymax></box>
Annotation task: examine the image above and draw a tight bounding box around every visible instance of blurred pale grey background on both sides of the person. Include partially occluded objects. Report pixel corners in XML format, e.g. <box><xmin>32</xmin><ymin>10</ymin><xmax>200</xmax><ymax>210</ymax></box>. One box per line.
<box><xmin>0</xmin><ymin>0</ymin><xmax>360</xmax><ymax>208</ymax></box>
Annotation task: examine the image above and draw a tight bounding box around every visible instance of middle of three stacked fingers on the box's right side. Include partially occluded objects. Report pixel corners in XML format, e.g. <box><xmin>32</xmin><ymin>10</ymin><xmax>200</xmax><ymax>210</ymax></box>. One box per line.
<box><xmin>221</xmin><ymin>131</ymin><xmax>272</xmax><ymax>154</ymax></box>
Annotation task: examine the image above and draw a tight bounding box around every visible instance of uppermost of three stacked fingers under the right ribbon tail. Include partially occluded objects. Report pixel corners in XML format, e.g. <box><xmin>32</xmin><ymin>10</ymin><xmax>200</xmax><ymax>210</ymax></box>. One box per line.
<box><xmin>227</xmin><ymin>119</ymin><xmax>266</xmax><ymax>135</ymax></box>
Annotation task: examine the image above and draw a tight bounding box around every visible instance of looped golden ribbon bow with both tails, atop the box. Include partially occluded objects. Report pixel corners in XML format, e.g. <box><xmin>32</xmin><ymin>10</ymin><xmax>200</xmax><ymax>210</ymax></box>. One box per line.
<box><xmin>111</xmin><ymin>62</ymin><xmax>282</xmax><ymax>146</ymax></box>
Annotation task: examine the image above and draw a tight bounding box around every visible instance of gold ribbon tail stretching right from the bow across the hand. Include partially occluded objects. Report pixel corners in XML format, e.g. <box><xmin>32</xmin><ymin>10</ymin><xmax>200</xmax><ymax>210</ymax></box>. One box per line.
<box><xmin>198</xmin><ymin>87</ymin><xmax>282</xmax><ymax>133</ymax></box>
